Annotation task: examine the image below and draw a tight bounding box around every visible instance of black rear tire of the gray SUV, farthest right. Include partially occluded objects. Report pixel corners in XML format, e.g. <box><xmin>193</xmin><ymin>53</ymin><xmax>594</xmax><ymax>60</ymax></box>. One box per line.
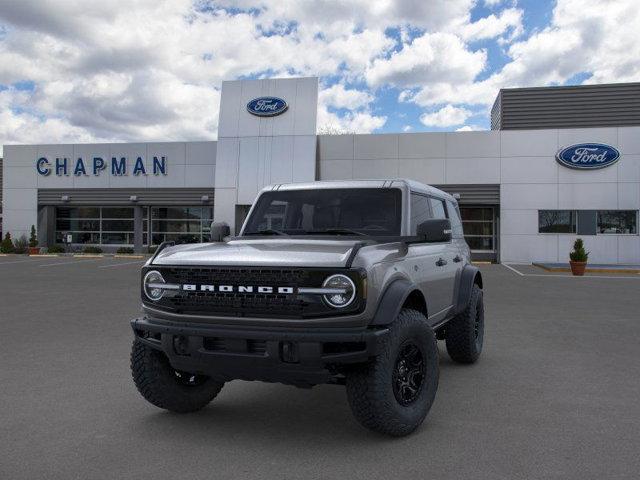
<box><xmin>445</xmin><ymin>284</ymin><xmax>484</xmax><ymax>363</ymax></box>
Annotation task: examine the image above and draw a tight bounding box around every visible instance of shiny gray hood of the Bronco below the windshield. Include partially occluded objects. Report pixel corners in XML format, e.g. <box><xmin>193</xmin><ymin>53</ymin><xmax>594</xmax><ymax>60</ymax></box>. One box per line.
<box><xmin>153</xmin><ymin>238</ymin><xmax>358</xmax><ymax>267</ymax></box>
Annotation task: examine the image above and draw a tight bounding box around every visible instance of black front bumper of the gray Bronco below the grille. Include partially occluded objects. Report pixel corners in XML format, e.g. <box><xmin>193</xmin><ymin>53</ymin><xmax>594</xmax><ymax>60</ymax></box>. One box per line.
<box><xmin>131</xmin><ymin>316</ymin><xmax>389</xmax><ymax>386</ymax></box>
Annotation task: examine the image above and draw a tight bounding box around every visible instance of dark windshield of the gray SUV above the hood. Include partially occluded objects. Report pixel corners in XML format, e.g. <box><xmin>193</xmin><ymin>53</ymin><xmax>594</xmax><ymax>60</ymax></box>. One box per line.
<box><xmin>243</xmin><ymin>188</ymin><xmax>402</xmax><ymax>236</ymax></box>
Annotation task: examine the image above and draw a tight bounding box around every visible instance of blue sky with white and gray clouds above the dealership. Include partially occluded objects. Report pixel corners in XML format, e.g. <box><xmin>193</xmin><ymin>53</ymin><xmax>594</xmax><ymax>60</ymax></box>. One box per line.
<box><xmin>0</xmin><ymin>0</ymin><xmax>640</xmax><ymax>154</ymax></box>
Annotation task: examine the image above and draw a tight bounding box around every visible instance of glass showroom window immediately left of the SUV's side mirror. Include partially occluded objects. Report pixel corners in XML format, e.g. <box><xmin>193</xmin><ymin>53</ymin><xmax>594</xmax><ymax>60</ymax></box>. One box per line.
<box><xmin>145</xmin><ymin>207</ymin><xmax>213</xmax><ymax>245</ymax></box>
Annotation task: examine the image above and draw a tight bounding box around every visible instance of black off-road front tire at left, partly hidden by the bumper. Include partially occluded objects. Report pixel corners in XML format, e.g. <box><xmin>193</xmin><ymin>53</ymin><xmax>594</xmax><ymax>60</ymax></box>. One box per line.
<box><xmin>131</xmin><ymin>340</ymin><xmax>224</xmax><ymax>413</ymax></box>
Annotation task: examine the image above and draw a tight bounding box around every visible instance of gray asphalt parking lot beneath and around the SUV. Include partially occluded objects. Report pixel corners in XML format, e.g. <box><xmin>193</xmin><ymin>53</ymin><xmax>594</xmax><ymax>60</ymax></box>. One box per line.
<box><xmin>0</xmin><ymin>256</ymin><xmax>640</xmax><ymax>480</ymax></box>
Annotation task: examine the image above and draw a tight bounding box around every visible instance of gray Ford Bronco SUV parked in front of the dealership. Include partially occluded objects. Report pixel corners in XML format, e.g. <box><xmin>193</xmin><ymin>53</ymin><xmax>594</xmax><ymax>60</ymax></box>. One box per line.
<box><xmin>131</xmin><ymin>180</ymin><xmax>484</xmax><ymax>435</ymax></box>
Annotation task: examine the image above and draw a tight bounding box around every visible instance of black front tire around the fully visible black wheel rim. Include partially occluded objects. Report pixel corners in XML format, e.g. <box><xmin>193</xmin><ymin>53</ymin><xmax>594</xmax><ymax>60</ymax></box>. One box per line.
<box><xmin>346</xmin><ymin>309</ymin><xmax>439</xmax><ymax>436</ymax></box>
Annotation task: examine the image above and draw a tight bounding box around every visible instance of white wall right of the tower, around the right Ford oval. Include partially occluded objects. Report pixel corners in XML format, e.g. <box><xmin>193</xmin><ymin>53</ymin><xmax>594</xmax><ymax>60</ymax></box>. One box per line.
<box><xmin>318</xmin><ymin>127</ymin><xmax>640</xmax><ymax>263</ymax></box>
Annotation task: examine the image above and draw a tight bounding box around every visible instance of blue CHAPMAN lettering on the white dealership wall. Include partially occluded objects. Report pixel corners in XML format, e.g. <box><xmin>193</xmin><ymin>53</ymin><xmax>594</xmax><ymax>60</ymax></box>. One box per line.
<box><xmin>36</xmin><ymin>157</ymin><xmax>167</xmax><ymax>177</ymax></box>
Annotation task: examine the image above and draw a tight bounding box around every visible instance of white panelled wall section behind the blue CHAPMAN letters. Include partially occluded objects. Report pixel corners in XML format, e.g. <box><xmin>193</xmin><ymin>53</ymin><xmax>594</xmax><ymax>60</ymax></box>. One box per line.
<box><xmin>2</xmin><ymin>142</ymin><xmax>216</xmax><ymax>239</ymax></box>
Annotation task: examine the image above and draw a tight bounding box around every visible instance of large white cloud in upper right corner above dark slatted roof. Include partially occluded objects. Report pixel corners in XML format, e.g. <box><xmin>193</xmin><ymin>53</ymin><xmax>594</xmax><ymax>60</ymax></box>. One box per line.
<box><xmin>403</xmin><ymin>0</ymin><xmax>640</xmax><ymax>113</ymax></box>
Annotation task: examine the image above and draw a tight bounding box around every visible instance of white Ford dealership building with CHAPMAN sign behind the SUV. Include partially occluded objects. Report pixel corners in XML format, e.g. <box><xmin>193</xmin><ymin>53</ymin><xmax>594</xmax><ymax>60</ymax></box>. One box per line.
<box><xmin>0</xmin><ymin>78</ymin><xmax>640</xmax><ymax>264</ymax></box>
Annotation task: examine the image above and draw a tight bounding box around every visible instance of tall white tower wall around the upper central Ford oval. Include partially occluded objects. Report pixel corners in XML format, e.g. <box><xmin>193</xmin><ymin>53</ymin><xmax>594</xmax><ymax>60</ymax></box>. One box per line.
<box><xmin>214</xmin><ymin>77</ymin><xmax>318</xmax><ymax>232</ymax></box>
